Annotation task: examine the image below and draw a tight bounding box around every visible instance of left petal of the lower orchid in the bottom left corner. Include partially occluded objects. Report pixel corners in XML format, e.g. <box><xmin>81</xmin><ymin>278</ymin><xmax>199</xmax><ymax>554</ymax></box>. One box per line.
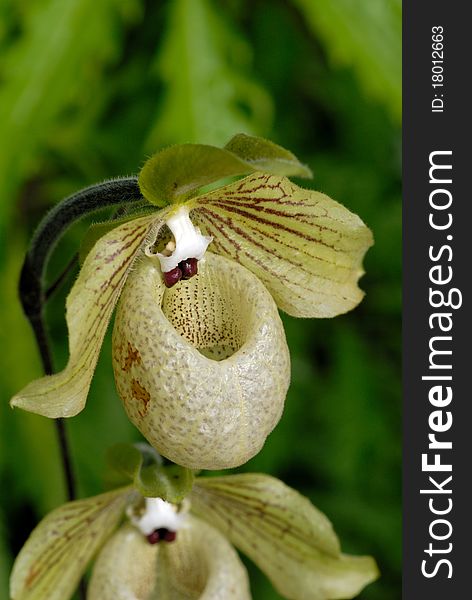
<box><xmin>10</xmin><ymin>488</ymin><xmax>135</xmax><ymax>600</ymax></box>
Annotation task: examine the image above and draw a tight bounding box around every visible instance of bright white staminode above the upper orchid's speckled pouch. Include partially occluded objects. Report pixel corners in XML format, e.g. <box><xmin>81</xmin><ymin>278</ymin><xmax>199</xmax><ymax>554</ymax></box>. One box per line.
<box><xmin>153</xmin><ymin>206</ymin><xmax>213</xmax><ymax>273</ymax></box>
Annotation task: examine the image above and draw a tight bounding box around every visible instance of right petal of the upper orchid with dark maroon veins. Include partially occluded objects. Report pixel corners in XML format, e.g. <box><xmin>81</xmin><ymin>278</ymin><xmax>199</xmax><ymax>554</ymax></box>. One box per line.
<box><xmin>188</xmin><ymin>173</ymin><xmax>372</xmax><ymax>317</ymax></box>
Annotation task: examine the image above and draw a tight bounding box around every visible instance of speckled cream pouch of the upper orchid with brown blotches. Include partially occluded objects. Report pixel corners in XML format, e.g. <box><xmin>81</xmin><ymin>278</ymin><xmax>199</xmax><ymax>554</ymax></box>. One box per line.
<box><xmin>113</xmin><ymin>252</ymin><xmax>290</xmax><ymax>469</ymax></box>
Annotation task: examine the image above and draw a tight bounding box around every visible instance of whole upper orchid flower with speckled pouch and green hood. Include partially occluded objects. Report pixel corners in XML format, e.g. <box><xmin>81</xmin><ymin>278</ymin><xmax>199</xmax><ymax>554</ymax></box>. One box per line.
<box><xmin>11</xmin><ymin>134</ymin><xmax>372</xmax><ymax>469</ymax></box>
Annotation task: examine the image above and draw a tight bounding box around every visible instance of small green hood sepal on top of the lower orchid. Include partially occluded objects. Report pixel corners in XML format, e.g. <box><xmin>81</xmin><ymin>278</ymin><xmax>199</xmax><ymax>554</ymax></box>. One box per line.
<box><xmin>108</xmin><ymin>443</ymin><xmax>193</xmax><ymax>504</ymax></box>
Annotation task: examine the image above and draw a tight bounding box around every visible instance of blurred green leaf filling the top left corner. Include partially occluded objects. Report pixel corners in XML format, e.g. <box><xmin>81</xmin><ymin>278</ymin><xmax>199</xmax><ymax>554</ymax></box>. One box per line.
<box><xmin>0</xmin><ymin>0</ymin><xmax>138</xmax><ymax>254</ymax></box>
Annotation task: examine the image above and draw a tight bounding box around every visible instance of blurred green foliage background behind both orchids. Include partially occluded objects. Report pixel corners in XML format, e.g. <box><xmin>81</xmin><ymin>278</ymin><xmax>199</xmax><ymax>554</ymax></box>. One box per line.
<box><xmin>0</xmin><ymin>0</ymin><xmax>401</xmax><ymax>600</ymax></box>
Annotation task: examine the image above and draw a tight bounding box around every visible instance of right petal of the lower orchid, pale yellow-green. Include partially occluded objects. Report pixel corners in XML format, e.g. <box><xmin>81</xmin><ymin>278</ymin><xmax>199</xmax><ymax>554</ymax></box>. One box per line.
<box><xmin>190</xmin><ymin>474</ymin><xmax>378</xmax><ymax>600</ymax></box>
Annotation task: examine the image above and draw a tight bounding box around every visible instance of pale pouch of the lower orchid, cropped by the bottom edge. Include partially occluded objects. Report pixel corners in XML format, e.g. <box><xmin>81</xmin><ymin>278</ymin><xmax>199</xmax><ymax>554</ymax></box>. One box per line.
<box><xmin>87</xmin><ymin>516</ymin><xmax>250</xmax><ymax>600</ymax></box>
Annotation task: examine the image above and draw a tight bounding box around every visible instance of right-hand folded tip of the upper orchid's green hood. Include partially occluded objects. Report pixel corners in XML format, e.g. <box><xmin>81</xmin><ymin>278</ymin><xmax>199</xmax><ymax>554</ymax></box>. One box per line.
<box><xmin>225</xmin><ymin>133</ymin><xmax>313</xmax><ymax>177</ymax></box>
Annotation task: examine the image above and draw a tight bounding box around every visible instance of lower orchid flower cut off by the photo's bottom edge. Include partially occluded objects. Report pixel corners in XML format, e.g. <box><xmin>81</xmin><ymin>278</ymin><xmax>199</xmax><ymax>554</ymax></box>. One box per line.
<box><xmin>11</xmin><ymin>442</ymin><xmax>378</xmax><ymax>600</ymax></box>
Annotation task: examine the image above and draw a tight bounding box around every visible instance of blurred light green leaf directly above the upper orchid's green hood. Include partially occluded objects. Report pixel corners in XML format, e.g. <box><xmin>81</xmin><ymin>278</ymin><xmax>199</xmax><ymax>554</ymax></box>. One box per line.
<box><xmin>147</xmin><ymin>0</ymin><xmax>273</xmax><ymax>151</ymax></box>
